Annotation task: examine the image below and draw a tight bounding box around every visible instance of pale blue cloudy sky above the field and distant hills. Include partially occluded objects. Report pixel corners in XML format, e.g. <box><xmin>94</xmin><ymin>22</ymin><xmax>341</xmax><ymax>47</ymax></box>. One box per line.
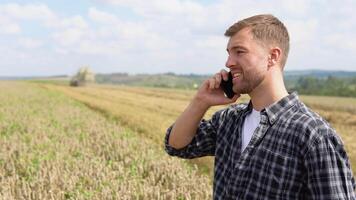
<box><xmin>0</xmin><ymin>0</ymin><xmax>356</xmax><ymax>76</ymax></box>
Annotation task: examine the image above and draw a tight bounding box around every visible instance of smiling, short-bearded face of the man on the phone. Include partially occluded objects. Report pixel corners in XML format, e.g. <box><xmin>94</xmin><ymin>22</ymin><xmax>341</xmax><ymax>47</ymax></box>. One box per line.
<box><xmin>226</xmin><ymin>28</ymin><xmax>269</xmax><ymax>94</ymax></box>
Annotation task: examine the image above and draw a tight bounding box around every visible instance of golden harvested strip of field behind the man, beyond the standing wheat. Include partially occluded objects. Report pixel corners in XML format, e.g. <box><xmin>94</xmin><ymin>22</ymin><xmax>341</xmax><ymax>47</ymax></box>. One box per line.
<box><xmin>42</xmin><ymin>81</ymin><xmax>356</xmax><ymax>173</ymax></box>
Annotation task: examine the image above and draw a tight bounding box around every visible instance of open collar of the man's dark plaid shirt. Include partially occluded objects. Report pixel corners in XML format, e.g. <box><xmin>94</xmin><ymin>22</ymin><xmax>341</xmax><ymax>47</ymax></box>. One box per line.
<box><xmin>243</xmin><ymin>92</ymin><xmax>299</xmax><ymax>124</ymax></box>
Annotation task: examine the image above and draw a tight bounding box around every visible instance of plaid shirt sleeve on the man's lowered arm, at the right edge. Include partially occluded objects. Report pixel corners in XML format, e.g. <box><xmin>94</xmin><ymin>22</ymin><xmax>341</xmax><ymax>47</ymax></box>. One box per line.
<box><xmin>305</xmin><ymin>130</ymin><xmax>356</xmax><ymax>200</ymax></box>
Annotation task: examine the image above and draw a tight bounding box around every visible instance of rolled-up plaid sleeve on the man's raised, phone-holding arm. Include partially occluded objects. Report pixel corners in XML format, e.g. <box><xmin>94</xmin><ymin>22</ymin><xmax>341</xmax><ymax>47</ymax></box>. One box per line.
<box><xmin>165</xmin><ymin>110</ymin><xmax>224</xmax><ymax>159</ymax></box>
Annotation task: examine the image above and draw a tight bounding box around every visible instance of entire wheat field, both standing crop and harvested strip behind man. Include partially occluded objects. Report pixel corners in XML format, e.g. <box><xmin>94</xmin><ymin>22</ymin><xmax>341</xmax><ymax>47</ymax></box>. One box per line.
<box><xmin>0</xmin><ymin>82</ymin><xmax>356</xmax><ymax>199</ymax></box>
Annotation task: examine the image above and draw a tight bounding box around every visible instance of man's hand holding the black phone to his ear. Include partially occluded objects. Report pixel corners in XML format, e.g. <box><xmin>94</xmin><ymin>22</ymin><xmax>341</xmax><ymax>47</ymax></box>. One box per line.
<box><xmin>193</xmin><ymin>70</ymin><xmax>240</xmax><ymax>108</ymax></box>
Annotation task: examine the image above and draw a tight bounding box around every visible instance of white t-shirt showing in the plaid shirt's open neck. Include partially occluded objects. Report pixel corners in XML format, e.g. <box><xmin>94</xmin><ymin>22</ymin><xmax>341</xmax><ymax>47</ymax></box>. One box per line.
<box><xmin>242</xmin><ymin>109</ymin><xmax>261</xmax><ymax>151</ymax></box>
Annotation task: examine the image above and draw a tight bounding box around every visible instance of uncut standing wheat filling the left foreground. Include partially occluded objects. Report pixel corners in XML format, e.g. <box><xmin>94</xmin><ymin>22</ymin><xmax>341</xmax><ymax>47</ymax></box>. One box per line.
<box><xmin>0</xmin><ymin>82</ymin><xmax>211</xmax><ymax>200</ymax></box>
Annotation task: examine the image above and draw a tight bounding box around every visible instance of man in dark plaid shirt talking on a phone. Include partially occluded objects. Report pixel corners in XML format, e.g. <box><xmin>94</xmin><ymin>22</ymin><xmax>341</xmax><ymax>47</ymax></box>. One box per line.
<box><xmin>165</xmin><ymin>15</ymin><xmax>355</xmax><ymax>200</ymax></box>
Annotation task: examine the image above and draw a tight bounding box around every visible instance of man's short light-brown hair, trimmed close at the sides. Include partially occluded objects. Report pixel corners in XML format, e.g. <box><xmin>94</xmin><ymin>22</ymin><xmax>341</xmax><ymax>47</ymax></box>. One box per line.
<box><xmin>225</xmin><ymin>14</ymin><xmax>289</xmax><ymax>69</ymax></box>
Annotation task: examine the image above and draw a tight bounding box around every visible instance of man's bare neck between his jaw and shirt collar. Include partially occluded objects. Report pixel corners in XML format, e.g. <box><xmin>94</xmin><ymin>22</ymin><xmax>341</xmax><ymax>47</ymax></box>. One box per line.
<box><xmin>249</xmin><ymin>69</ymin><xmax>288</xmax><ymax>111</ymax></box>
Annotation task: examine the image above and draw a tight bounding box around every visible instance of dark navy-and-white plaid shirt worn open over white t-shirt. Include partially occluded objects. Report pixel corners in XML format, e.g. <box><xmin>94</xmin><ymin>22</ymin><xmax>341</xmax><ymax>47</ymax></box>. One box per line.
<box><xmin>165</xmin><ymin>93</ymin><xmax>356</xmax><ymax>200</ymax></box>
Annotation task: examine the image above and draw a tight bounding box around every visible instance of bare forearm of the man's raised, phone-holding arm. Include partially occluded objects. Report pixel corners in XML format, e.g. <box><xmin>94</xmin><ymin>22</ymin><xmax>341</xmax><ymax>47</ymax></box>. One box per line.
<box><xmin>168</xmin><ymin>98</ymin><xmax>209</xmax><ymax>149</ymax></box>
